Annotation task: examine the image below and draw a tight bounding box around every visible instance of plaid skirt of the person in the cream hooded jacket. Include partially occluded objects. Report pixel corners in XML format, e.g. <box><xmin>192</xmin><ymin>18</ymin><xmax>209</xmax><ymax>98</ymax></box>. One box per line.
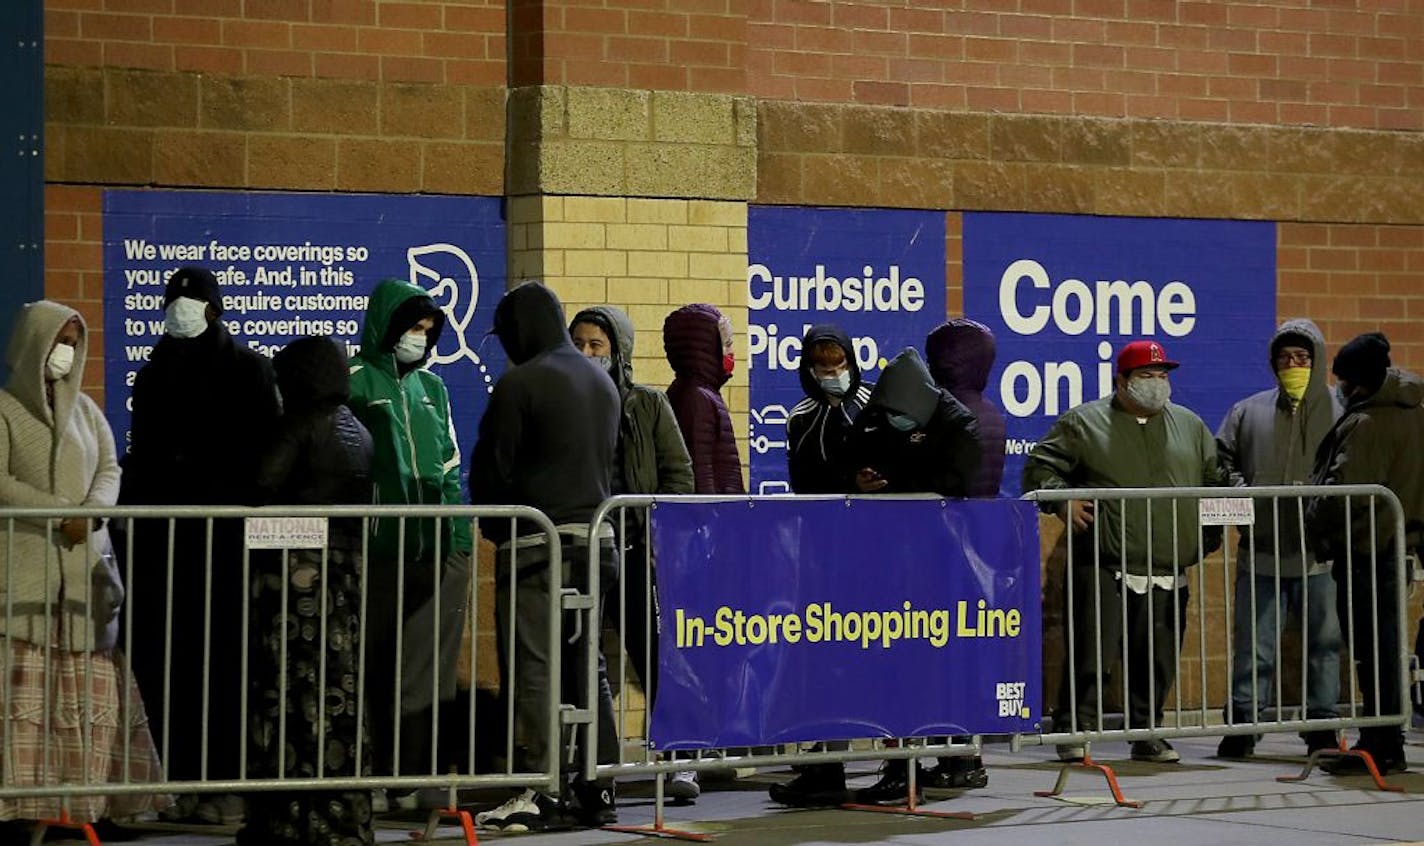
<box><xmin>0</xmin><ymin>637</ymin><xmax>169</xmax><ymax>822</ymax></box>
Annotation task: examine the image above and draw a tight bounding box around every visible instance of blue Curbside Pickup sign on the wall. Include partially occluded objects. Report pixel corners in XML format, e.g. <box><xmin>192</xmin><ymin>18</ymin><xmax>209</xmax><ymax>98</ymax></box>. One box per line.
<box><xmin>746</xmin><ymin>205</ymin><xmax>944</xmax><ymax>493</ymax></box>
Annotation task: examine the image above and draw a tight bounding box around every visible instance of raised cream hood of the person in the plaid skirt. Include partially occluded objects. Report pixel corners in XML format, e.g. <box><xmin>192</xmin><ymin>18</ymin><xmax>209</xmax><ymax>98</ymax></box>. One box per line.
<box><xmin>6</xmin><ymin>299</ymin><xmax>88</xmax><ymax>426</ymax></box>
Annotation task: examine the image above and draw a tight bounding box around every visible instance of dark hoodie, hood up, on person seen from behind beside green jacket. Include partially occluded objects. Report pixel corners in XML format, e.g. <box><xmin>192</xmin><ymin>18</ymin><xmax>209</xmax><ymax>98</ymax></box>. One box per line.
<box><xmin>470</xmin><ymin>282</ymin><xmax>619</xmax><ymax>540</ymax></box>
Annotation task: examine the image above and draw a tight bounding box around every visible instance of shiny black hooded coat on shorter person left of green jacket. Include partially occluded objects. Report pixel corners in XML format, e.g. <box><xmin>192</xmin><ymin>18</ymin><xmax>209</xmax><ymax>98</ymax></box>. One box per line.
<box><xmin>258</xmin><ymin>338</ymin><xmax>373</xmax><ymax>551</ymax></box>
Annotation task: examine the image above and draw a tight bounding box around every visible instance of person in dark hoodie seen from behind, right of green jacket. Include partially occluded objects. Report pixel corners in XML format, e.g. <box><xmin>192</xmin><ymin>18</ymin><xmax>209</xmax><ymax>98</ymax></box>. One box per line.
<box><xmin>470</xmin><ymin>282</ymin><xmax>621</xmax><ymax>830</ymax></box>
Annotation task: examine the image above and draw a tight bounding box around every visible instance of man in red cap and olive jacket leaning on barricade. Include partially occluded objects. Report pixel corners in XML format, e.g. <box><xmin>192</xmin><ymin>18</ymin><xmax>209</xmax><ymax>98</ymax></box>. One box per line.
<box><xmin>1024</xmin><ymin>340</ymin><xmax>1226</xmax><ymax>763</ymax></box>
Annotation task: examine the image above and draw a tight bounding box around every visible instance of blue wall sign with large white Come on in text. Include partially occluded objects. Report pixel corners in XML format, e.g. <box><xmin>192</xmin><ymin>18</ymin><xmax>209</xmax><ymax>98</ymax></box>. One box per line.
<box><xmin>964</xmin><ymin>212</ymin><xmax>1276</xmax><ymax>496</ymax></box>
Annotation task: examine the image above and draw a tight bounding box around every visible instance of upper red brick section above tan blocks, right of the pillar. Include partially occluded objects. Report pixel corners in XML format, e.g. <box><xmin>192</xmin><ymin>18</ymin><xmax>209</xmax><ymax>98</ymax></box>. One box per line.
<box><xmin>748</xmin><ymin>0</ymin><xmax>1424</xmax><ymax>130</ymax></box>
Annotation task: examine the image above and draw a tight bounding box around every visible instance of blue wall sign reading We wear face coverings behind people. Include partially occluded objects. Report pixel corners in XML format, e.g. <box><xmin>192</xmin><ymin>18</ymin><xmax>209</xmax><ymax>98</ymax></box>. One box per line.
<box><xmin>104</xmin><ymin>191</ymin><xmax>506</xmax><ymax>484</ymax></box>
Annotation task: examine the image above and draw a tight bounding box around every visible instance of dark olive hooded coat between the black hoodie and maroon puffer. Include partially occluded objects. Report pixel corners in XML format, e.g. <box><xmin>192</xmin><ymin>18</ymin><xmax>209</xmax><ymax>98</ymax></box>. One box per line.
<box><xmin>570</xmin><ymin>305</ymin><xmax>692</xmax><ymax>494</ymax></box>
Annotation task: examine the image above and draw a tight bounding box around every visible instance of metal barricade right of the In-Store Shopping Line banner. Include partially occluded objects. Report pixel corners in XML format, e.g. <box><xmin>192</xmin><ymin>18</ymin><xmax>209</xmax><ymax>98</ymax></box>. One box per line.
<box><xmin>1022</xmin><ymin>484</ymin><xmax>1411</xmax><ymax>772</ymax></box>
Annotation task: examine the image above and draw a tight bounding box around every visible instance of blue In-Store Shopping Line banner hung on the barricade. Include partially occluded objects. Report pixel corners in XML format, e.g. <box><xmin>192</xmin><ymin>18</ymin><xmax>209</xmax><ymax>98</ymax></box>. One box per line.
<box><xmin>651</xmin><ymin>497</ymin><xmax>1042</xmax><ymax>749</ymax></box>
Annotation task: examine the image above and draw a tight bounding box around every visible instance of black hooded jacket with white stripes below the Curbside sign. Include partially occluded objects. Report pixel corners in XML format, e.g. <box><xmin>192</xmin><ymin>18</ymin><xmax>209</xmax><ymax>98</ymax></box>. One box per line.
<box><xmin>786</xmin><ymin>323</ymin><xmax>874</xmax><ymax>494</ymax></box>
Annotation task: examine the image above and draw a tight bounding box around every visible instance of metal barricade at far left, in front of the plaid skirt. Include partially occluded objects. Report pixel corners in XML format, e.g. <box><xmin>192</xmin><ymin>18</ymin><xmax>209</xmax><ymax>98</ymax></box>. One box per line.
<box><xmin>0</xmin><ymin>506</ymin><xmax>567</xmax><ymax>830</ymax></box>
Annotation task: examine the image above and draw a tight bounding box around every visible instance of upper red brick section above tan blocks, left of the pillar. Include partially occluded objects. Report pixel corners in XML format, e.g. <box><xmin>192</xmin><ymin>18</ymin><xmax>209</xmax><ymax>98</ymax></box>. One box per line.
<box><xmin>44</xmin><ymin>0</ymin><xmax>506</xmax><ymax>85</ymax></box>
